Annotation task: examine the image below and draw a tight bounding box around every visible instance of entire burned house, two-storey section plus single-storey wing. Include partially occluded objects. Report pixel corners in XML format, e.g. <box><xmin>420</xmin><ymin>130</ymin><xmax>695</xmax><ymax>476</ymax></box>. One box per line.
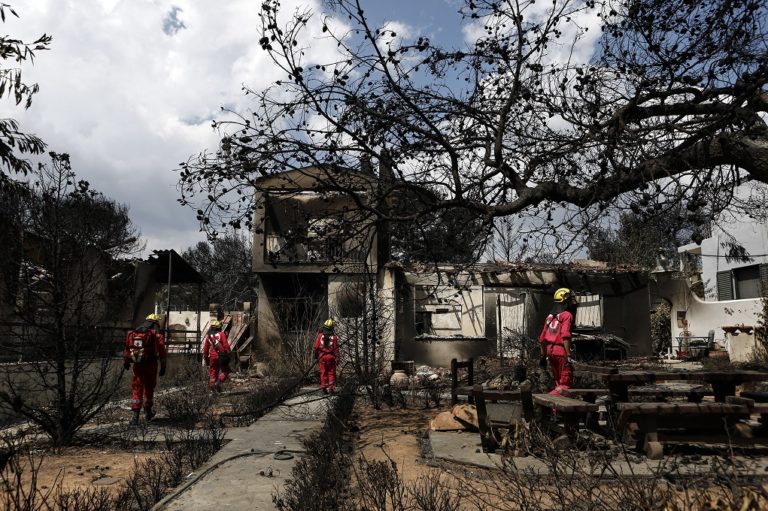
<box><xmin>253</xmin><ymin>166</ymin><xmax>651</xmax><ymax>366</ymax></box>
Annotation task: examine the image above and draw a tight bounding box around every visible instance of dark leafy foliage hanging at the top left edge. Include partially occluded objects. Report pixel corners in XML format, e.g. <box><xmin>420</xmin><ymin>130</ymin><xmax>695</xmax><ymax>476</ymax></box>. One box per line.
<box><xmin>0</xmin><ymin>3</ymin><xmax>51</xmax><ymax>181</ymax></box>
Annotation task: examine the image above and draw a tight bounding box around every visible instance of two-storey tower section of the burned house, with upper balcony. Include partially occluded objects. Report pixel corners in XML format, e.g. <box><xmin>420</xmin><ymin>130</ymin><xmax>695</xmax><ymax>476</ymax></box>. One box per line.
<box><xmin>253</xmin><ymin>167</ymin><xmax>391</xmax><ymax>357</ymax></box>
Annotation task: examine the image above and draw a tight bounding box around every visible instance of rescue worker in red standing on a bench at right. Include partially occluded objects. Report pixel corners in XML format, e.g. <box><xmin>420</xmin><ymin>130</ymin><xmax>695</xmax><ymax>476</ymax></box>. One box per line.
<box><xmin>539</xmin><ymin>287</ymin><xmax>578</xmax><ymax>395</ymax></box>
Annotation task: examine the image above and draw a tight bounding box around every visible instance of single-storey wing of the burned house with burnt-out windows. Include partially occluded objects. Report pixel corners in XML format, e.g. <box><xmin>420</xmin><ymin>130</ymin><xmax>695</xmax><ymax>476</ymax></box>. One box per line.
<box><xmin>388</xmin><ymin>261</ymin><xmax>651</xmax><ymax>366</ymax></box>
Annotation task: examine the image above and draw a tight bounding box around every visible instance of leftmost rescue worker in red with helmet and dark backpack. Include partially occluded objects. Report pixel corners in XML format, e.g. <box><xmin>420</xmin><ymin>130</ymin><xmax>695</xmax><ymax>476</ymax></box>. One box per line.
<box><xmin>123</xmin><ymin>314</ymin><xmax>168</xmax><ymax>424</ymax></box>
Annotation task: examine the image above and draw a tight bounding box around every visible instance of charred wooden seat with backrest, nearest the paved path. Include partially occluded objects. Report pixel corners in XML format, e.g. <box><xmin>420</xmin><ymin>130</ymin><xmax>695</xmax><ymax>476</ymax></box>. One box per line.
<box><xmin>470</xmin><ymin>384</ymin><xmax>533</xmax><ymax>452</ymax></box>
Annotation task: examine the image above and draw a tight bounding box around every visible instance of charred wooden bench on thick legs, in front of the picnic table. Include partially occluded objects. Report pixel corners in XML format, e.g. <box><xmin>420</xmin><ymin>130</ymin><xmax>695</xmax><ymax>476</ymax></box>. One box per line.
<box><xmin>616</xmin><ymin>403</ymin><xmax>751</xmax><ymax>460</ymax></box>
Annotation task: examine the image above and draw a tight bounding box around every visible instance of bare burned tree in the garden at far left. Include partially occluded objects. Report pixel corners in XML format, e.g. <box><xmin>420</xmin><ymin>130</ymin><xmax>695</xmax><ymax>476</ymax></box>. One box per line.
<box><xmin>0</xmin><ymin>153</ymin><xmax>138</xmax><ymax>445</ymax></box>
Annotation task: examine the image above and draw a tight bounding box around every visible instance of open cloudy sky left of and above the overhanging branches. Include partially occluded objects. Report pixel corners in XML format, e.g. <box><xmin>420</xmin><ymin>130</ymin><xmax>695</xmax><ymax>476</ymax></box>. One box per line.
<box><xmin>0</xmin><ymin>0</ymin><xmax>600</xmax><ymax>255</ymax></box>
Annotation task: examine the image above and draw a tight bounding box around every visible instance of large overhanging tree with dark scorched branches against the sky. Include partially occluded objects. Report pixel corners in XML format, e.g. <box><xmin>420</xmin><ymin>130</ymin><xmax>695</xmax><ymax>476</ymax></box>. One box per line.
<box><xmin>180</xmin><ymin>0</ymin><xmax>768</xmax><ymax>260</ymax></box>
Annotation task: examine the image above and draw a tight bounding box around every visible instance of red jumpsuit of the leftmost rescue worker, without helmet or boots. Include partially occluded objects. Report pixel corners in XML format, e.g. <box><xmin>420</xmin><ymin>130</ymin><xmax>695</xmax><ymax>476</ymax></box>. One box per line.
<box><xmin>123</xmin><ymin>328</ymin><xmax>168</xmax><ymax>411</ymax></box>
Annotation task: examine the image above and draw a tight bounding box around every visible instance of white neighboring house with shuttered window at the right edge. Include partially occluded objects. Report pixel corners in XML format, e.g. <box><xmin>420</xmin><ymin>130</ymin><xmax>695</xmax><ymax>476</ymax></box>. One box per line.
<box><xmin>655</xmin><ymin>183</ymin><xmax>768</xmax><ymax>361</ymax></box>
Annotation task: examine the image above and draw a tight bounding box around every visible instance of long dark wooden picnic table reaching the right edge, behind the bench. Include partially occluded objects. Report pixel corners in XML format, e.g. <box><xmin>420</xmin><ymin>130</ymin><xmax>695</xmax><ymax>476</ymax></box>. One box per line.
<box><xmin>603</xmin><ymin>370</ymin><xmax>768</xmax><ymax>403</ymax></box>
